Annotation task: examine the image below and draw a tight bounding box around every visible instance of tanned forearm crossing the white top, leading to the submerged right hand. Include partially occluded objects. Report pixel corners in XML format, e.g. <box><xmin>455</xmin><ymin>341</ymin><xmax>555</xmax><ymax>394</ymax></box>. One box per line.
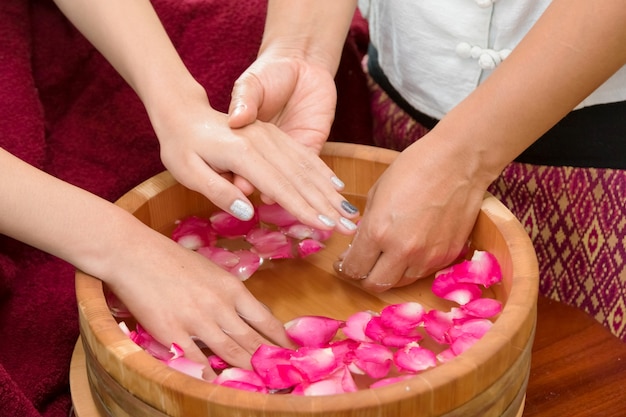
<box><xmin>433</xmin><ymin>0</ymin><xmax>626</xmax><ymax>179</ymax></box>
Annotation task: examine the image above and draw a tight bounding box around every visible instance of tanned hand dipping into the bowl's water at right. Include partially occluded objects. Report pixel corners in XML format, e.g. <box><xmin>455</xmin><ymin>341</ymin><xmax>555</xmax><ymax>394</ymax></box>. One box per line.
<box><xmin>335</xmin><ymin>134</ymin><xmax>488</xmax><ymax>292</ymax></box>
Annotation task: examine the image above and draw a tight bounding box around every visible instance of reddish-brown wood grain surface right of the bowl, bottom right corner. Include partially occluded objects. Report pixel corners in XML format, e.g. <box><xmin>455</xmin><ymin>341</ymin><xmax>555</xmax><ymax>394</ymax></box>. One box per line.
<box><xmin>524</xmin><ymin>297</ymin><xmax>626</xmax><ymax>417</ymax></box>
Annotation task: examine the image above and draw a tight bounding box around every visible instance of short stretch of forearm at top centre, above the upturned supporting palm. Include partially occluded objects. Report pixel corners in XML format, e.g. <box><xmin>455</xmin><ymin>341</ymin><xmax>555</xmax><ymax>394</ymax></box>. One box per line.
<box><xmin>261</xmin><ymin>0</ymin><xmax>356</xmax><ymax>75</ymax></box>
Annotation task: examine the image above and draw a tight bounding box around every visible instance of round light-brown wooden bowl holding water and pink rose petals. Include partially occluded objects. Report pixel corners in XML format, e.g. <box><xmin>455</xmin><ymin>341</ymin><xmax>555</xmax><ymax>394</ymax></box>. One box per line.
<box><xmin>76</xmin><ymin>143</ymin><xmax>538</xmax><ymax>417</ymax></box>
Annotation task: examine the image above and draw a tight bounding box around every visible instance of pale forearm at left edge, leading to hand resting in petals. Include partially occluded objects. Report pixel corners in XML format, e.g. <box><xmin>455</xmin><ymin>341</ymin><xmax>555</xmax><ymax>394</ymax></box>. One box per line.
<box><xmin>0</xmin><ymin>148</ymin><xmax>155</xmax><ymax>277</ymax></box>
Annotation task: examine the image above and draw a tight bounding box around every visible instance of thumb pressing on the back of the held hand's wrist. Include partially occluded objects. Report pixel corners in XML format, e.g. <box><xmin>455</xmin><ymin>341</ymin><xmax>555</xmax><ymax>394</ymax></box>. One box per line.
<box><xmin>228</xmin><ymin>73</ymin><xmax>263</xmax><ymax>129</ymax></box>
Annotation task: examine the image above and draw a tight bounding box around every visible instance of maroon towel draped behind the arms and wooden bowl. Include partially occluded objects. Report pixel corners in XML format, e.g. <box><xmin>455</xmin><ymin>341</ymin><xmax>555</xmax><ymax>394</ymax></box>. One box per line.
<box><xmin>0</xmin><ymin>0</ymin><xmax>371</xmax><ymax>417</ymax></box>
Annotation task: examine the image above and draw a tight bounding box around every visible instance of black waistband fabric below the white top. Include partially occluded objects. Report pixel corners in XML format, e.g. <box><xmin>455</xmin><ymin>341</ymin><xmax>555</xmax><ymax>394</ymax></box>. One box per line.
<box><xmin>368</xmin><ymin>45</ymin><xmax>626</xmax><ymax>169</ymax></box>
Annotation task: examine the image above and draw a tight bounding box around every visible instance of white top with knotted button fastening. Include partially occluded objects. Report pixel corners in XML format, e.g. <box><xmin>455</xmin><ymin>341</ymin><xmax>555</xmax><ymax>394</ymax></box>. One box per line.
<box><xmin>359</xmin><ymin>0</ymin><xmax>626</xmax><ymax>119</ymax></box>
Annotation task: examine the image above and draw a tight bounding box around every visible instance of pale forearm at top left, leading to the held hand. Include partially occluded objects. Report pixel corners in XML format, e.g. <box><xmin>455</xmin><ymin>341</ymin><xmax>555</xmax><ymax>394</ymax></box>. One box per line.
<box><xmin>55</xmin><ymin>0</ymin><xmax>201</xmax><ymax>110</ymax></box>
